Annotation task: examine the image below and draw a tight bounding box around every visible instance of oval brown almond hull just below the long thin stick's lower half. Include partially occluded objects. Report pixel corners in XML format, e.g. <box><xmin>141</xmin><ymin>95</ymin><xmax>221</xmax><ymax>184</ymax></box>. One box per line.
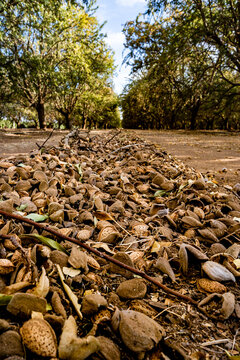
<box><xmin>117</xmin><ymin>279</ymin><xmax>147</xmax><ymax>299</ymax></box>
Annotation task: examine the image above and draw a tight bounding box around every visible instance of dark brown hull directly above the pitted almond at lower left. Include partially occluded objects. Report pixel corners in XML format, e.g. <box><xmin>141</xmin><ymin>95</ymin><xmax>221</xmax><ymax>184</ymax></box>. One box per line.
<box><xmin>7</xmin><ymin>293</ymin><xmax>47</xmax><ymax>317</ymax></box>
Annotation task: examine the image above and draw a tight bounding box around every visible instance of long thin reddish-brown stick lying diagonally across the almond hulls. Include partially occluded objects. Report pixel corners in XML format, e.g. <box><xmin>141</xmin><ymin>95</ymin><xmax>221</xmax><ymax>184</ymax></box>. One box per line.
<box><xmin>0</xmin><ymin>210</ymin><xmax>198</xmax><ymax>305</ymax></box>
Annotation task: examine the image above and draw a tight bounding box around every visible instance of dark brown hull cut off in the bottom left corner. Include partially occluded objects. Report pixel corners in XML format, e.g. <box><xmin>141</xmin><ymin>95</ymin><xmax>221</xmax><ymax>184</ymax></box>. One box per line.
<box><xmin>0</xmin><ymin>330</ymin><xmax>24</xmax><ymax>360</ymax></box>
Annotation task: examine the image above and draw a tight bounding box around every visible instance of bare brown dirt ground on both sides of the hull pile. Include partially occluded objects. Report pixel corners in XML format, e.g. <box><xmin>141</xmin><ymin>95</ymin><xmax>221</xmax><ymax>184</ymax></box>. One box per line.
<box><xmin>0</xmin><ymin>129</ymin><xmax>240</xmax><ymax>185</ymax></box>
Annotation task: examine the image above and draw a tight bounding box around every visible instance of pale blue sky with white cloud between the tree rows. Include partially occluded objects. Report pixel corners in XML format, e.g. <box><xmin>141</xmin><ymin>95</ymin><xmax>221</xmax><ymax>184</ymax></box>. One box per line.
<box><xmin>96</xmin><ymin>0</ymin><xmax>146</xmax><ymax>94</ymax></box>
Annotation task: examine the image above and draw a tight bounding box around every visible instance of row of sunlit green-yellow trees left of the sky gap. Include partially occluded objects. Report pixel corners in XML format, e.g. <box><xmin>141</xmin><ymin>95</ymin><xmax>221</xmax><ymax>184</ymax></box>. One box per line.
<box><xmin>0</xmin><ymin>0</ymin><xmax>120</xmax><ymax>128</ymax></box>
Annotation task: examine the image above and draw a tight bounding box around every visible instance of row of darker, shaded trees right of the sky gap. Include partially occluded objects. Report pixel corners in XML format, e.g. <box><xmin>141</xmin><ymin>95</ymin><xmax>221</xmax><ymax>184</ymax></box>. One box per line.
<box><xmin>122</xmin><ymin>0</ymin><xmax>240</xmax><ymax>129</ymax></box>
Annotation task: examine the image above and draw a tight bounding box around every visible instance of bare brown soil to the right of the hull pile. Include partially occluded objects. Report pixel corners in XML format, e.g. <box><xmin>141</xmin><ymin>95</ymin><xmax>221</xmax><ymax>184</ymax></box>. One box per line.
<box><xmin>131</xmin><ymin>130</ymin><xmax>240</xmax><ymax>185</ymax></box>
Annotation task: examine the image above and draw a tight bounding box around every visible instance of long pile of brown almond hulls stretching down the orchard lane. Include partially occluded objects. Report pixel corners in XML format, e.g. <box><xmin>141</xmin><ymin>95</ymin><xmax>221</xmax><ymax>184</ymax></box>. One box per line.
<box><xmin>0</xmin><ymin>131</ymin><xmax>240</xmax><ymax>360</ymax></box>
